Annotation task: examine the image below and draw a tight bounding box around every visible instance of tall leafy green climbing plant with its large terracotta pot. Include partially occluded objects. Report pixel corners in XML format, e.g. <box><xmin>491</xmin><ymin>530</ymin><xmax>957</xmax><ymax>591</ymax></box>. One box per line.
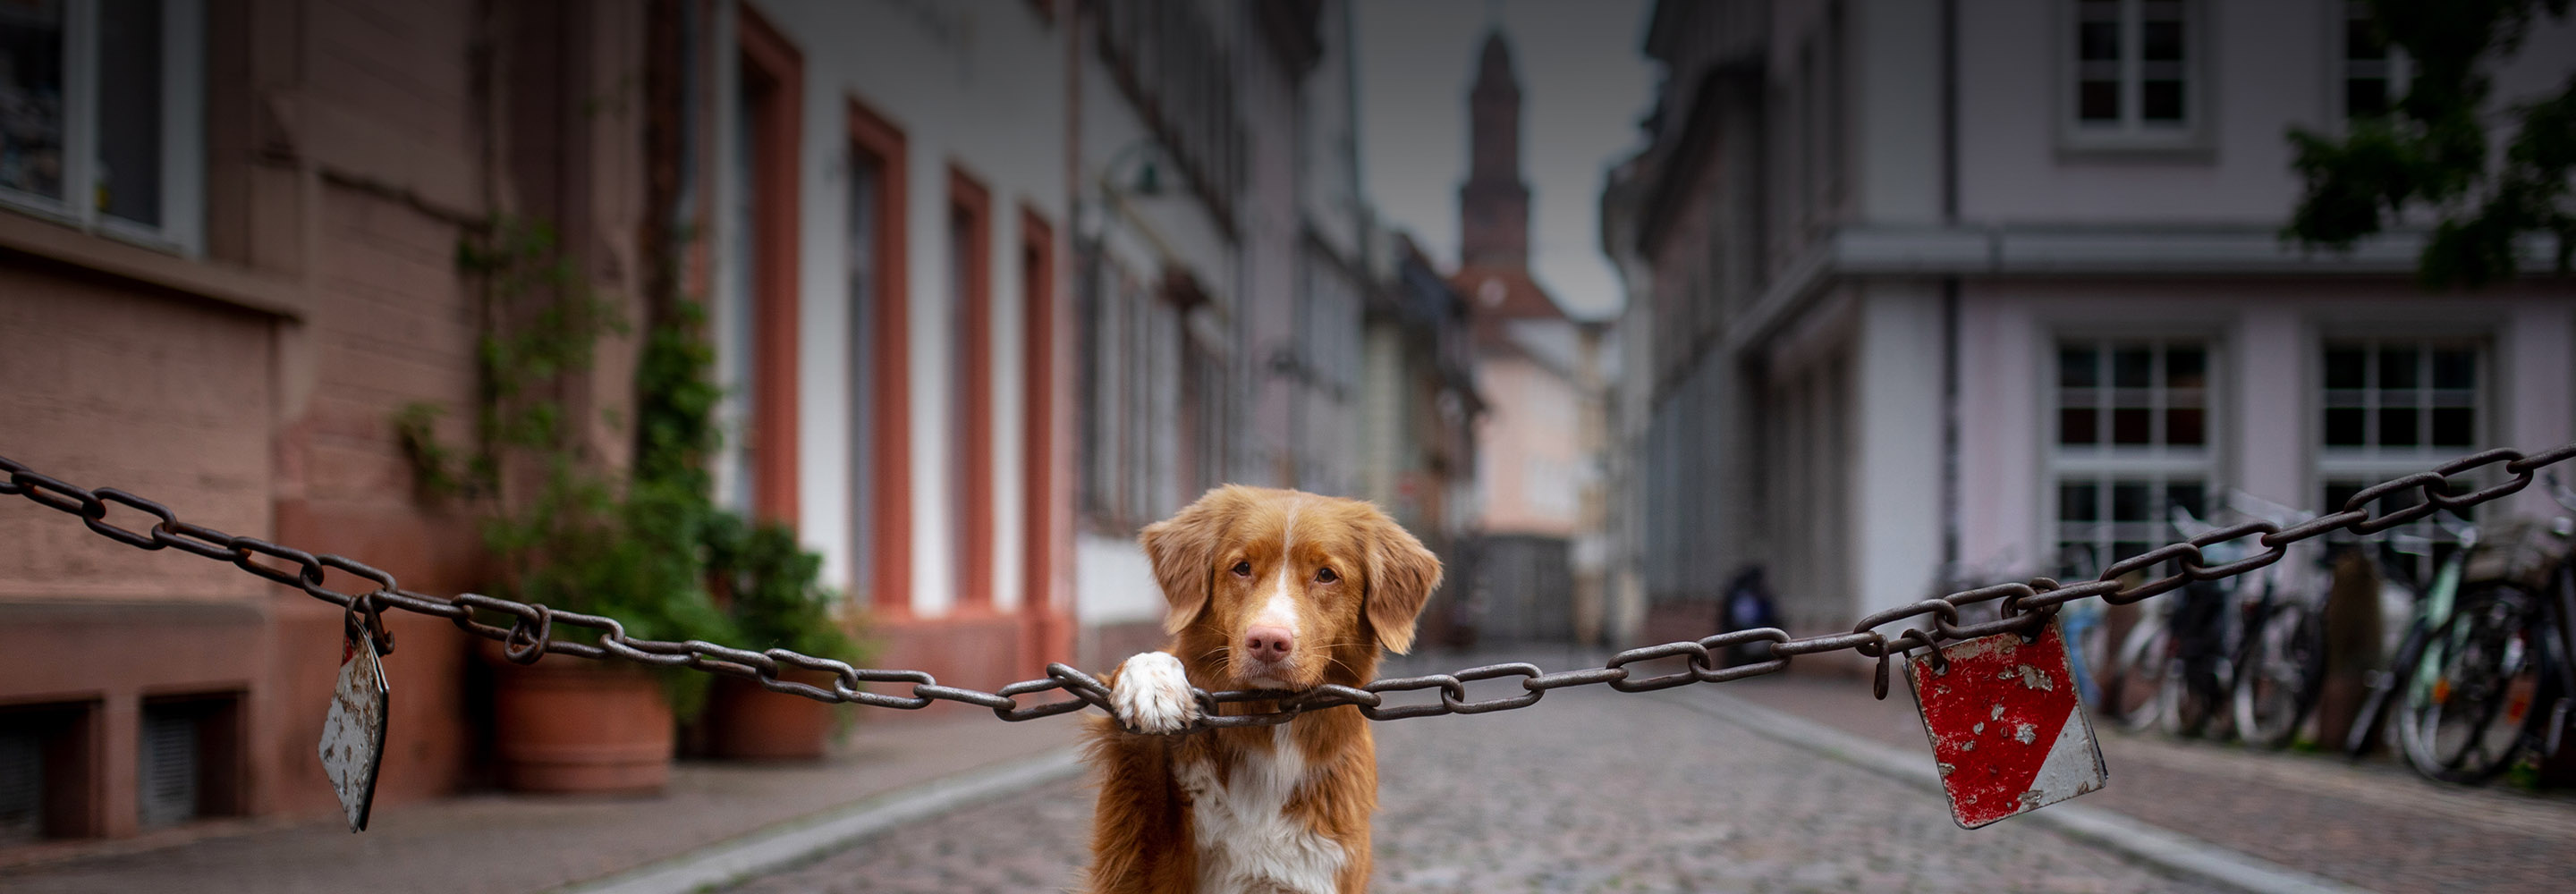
<box><xmin>394</xmin><ymin>219</ymin><xmax>734</xmax><ymax>791</ymax></box>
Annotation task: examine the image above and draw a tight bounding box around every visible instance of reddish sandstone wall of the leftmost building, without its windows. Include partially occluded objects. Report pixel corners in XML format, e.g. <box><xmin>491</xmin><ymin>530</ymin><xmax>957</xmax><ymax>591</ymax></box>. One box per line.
<box><xmin>0</xmin><ymin>0</ymin><xmax>641</xmax><ymax>835</ymax></box>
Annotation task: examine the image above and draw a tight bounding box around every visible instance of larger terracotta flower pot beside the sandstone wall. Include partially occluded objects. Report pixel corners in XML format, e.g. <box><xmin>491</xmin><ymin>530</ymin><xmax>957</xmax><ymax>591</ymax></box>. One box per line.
<box><xmin>487</xmin><ymin>646</ymin><xmax>675</xmax><ymax>794</ymax></box>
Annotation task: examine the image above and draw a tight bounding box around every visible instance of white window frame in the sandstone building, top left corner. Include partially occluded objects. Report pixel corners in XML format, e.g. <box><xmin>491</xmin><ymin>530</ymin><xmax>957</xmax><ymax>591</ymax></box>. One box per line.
<box><xmin>0</xmin><ymin>0</ymin><xmax>206</xmax><ymax>257</ymax></box>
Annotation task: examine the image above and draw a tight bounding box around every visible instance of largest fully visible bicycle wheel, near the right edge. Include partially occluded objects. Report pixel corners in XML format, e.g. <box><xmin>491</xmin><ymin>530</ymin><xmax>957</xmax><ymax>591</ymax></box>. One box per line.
<box><xmin>2398</xmin><ymin>585</ymin><xmax>2540</xmax><ymax>786</ymax></box>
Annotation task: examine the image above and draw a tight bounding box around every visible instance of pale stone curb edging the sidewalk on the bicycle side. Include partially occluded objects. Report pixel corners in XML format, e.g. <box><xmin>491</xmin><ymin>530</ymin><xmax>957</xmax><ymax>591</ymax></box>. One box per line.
<box><xmin>1669</xmin><ymin>693</ymin><xmax>2370</xmax><ymax>894</ymax></box>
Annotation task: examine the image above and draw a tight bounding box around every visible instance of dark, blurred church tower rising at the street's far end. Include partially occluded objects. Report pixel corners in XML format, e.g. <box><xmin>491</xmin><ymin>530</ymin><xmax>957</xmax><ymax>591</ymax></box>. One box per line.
<box><xmin>1458</xmin><ymin>29</ymin><xmax>1530</xmax><ymax>271</ymax></box>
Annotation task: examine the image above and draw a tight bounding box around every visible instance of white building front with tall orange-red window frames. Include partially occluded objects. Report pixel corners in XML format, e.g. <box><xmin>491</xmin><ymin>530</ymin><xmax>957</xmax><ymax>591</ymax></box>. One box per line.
<box><xmin>693</xmin><ymin>0</ymin><xmax>1074</xmax><ymax>686</ymax></box>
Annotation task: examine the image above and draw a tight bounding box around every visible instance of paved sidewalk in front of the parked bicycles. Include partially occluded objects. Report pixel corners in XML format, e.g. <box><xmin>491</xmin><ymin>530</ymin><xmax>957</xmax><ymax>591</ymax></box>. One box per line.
<box><xmin>1724</xmin><ymin>675</ymin><xmax>2576</xmax><ymax>891</ymax></box>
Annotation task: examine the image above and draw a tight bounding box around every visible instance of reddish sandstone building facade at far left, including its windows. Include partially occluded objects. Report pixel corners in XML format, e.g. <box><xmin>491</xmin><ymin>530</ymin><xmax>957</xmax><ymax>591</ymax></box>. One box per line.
<box><xmin>0</xmin><ymin>0</ymin><xmax>647</xmax><ymax>845</ymax></box>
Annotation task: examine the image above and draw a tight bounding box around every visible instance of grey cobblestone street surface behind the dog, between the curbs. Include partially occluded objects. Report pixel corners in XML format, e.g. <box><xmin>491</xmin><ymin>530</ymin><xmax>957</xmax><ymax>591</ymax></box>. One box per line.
<box><xmin>737</xmin><ymin>690</ymin><xmax>2207</xmax><ymax>894</ymax></box>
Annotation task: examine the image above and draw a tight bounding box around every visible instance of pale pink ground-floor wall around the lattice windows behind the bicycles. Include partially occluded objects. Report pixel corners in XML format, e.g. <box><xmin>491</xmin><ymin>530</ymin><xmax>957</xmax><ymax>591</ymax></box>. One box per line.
<box><xmin>1961</xmin><ymin>281</ymin><xmax>2576</xmax><ymax>574</ymax></box>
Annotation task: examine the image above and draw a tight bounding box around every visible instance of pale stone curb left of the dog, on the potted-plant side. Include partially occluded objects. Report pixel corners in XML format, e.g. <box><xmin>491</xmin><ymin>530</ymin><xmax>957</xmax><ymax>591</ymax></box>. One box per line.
<box><xmin>548</xmin><ymin>747</ymin><xmax>1082</xmax><ymax>894</ymax></box>
